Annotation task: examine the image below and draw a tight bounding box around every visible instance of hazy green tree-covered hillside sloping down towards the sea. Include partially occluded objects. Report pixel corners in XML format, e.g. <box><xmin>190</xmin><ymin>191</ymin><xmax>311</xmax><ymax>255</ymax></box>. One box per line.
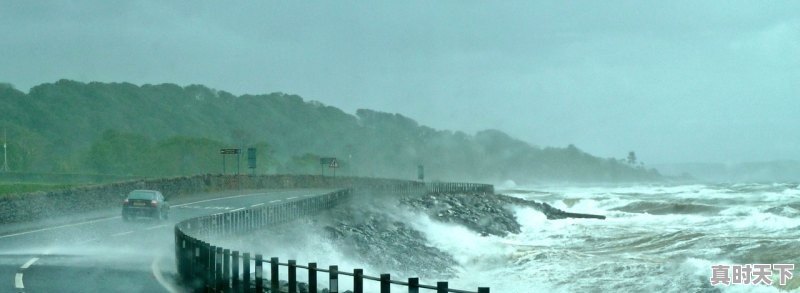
<box><xmin>0</xmin><ymin>80</ymin><xmax>660</xmax><ymax>182</ymax></box>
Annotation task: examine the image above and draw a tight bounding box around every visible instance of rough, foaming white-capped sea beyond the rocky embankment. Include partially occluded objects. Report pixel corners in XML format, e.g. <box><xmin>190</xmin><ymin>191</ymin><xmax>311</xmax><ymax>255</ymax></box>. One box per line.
<box><xmin>444</xmin><ymin>184</ymin><xmax>800</xmax><ymax>292</ymax></box>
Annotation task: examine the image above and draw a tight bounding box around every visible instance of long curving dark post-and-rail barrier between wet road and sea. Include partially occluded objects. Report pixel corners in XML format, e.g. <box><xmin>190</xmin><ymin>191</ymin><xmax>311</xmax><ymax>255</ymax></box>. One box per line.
<box><xmin>175</xmin><ymin>181</ymin><xmax>493</xmax><ymax>293</ymax></box>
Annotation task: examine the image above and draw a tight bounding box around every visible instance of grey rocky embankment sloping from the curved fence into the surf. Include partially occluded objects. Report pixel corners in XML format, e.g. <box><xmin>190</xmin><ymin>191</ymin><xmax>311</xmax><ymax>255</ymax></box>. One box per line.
<box><xmin>316</xmin><ymin>189</ymin><xmax>605</xmax><ymax>278</ymax></box>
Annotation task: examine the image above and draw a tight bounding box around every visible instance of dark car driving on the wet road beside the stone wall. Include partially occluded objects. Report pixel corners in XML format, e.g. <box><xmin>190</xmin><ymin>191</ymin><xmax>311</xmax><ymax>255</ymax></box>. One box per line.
<box><xmin>122</xmin><ymin>190</ymin><xmax>169</xmax><ymax>221</ymax></box>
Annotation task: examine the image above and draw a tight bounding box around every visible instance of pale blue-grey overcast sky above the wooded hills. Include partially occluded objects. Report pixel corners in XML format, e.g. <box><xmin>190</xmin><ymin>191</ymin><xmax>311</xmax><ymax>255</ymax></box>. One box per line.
<box><xmin>0</xmin><ymin>1</ymin><xmax>800</xmax><ymax>164</ymax></box>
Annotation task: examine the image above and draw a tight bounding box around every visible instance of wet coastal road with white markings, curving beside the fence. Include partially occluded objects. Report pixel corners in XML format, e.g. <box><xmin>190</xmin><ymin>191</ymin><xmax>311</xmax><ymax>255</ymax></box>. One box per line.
<box><xmin>0</xmin><ymin>189</ymin><xmax>330</xmax><ymax>292</ymax></box>
